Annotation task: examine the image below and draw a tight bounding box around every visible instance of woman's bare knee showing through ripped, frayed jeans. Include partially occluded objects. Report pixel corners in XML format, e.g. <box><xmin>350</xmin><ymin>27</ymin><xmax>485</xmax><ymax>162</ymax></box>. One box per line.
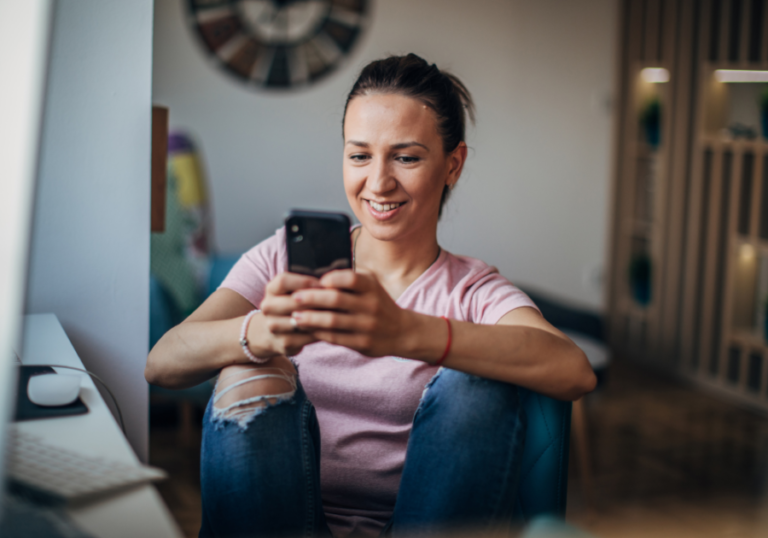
<box><xmin>213</xmin><ymin>357</ymin><xmax>297</xmax><ymax>426</ymax></box>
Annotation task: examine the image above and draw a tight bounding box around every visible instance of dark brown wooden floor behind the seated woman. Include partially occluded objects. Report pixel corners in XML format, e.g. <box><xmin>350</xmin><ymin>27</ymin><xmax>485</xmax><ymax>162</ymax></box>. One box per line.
<box><xmin>150</xmin><ymin>363</ymin><xmax>768</xmax><ymax>538</ymax></box>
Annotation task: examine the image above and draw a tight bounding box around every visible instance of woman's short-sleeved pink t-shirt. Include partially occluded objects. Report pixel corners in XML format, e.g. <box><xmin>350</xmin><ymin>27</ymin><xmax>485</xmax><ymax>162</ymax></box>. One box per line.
<box><xmin>221</xmin><ymin>228</ymin><xmax>536</xmax><ymax>538</ymax></box>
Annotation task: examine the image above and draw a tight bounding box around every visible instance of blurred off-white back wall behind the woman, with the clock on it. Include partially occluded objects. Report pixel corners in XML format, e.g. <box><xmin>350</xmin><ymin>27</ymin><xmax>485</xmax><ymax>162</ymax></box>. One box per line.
<box><xmin>153</xmin><ymin>0</ymin><xmax>617</xmax><ymax>309</ymax></box>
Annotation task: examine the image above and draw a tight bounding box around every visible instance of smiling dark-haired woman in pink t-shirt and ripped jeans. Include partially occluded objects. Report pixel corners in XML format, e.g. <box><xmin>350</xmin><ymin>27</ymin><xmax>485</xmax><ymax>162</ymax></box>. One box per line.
<box><xmin>146</xmin><ymin>54</ymin><xmax>595</xmax><ymax>538</ymax></box>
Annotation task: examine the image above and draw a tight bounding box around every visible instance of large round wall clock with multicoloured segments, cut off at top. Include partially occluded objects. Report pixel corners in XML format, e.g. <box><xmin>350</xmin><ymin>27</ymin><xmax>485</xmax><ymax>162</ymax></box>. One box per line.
<box><xmin>188</xmin><ymin>0</ymin><xmax>369</xmax><ymax>89</ymax></box>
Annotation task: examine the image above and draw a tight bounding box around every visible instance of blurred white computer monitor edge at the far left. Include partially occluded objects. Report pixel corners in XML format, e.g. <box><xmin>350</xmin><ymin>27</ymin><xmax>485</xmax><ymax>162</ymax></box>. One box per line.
<box><xmin>0</xmin><ymin>0</ymin><xmax>52</xmax><ymax>509</ymax></box>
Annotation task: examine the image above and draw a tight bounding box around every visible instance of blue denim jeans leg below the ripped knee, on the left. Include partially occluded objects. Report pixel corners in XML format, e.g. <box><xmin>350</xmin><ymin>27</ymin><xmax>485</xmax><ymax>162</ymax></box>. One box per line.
<box><xmin>200</xmin><ymin>376</ymin><xmax>331</xmax><ymax>538</ymax></box>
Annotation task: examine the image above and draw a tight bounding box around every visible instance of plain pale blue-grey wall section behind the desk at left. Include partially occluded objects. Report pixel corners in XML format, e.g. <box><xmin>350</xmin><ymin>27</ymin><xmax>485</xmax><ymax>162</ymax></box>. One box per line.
<box><xmin>27</xmin><ymin>0</ymin><xmax>153</xmax><ymax>461</ymax></box>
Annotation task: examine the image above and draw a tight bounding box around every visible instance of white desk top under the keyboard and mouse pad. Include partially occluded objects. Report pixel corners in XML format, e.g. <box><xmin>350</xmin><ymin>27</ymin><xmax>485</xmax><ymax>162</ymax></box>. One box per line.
<box><xmin>17</xmin><ymin>314</ymin><xmax>181</xmax><ymax>538</ymax></box>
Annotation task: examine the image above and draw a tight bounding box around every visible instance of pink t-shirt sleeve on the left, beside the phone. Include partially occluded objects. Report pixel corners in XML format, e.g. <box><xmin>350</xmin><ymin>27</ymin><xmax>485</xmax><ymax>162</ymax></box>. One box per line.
<box><xmin>219</xmin><ymin>228</ymin><xmax>286</xmax><ymax>308</ymax></box>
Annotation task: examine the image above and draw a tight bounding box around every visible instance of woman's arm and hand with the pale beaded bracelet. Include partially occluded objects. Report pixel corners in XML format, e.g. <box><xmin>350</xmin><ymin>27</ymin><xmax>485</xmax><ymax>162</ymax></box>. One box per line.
<box><xmin>144</xmin><ymin>273</ymin><xmax>317</xmax><ymax>389</ymax></box>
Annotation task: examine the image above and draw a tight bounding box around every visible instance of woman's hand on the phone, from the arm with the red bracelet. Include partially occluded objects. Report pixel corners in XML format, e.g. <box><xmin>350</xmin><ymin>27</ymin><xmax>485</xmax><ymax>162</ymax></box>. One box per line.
<box><xmin>291</xmin><ymin>270</ymin><xmax>413</xmax><ymax>357</ymax></box>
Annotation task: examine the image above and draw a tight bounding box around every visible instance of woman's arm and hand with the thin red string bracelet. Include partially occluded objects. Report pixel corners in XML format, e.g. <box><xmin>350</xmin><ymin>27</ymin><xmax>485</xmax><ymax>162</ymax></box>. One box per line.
<box><xmin>286</xmin><ymin>271</ymin><xmax>596</xmax><ymax>400</ymax></box>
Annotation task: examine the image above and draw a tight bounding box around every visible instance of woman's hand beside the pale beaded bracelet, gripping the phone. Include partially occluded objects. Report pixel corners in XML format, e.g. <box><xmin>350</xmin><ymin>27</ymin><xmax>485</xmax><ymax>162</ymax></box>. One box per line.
<box><xmin>255</xmin><ymin>273</ymin><xmax>320</xmax><ymax>358</ymax></box>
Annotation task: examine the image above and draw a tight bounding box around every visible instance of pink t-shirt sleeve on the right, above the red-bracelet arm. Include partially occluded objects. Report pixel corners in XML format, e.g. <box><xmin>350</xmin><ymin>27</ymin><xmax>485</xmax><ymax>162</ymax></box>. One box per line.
<box><xmin>467</xmin><ymin>267</ymin><xmax>539</xmax><ymax>325</ymax></box>
